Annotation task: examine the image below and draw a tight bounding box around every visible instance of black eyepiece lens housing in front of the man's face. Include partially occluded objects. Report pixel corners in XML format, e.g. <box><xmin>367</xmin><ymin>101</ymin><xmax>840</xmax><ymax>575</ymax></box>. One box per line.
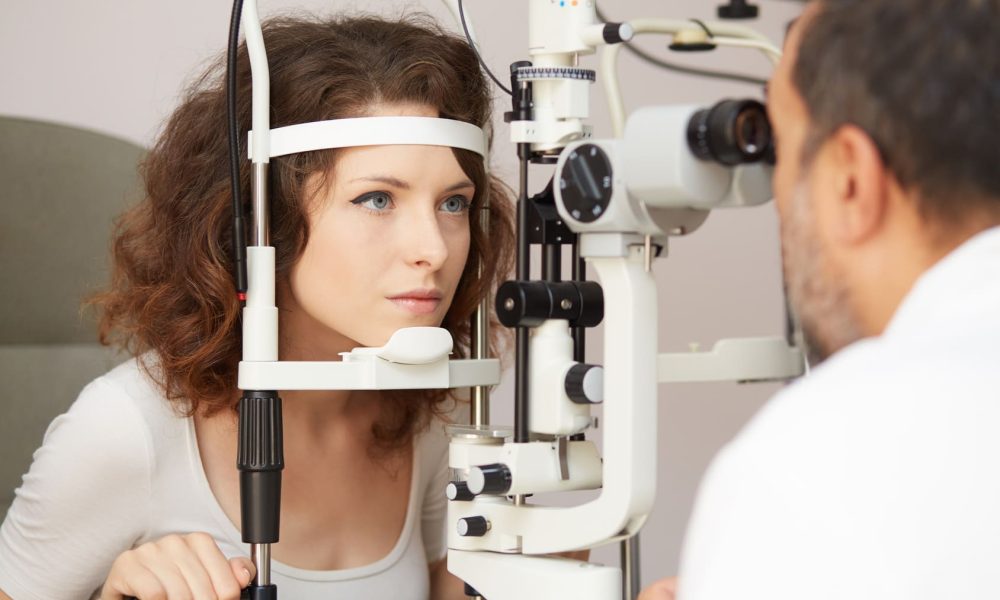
<box><xmin>687</xmin><ymin>100</ymin><xmax>773</xmax><ymax>167</ymax></box>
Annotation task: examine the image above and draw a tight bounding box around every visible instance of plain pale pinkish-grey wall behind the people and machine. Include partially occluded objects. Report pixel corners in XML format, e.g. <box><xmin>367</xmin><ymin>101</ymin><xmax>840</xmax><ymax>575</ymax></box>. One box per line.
<box><xmin>0</xmin><ymin>0</ymin><xmax>801</xmax><ymax>582</ymax></box>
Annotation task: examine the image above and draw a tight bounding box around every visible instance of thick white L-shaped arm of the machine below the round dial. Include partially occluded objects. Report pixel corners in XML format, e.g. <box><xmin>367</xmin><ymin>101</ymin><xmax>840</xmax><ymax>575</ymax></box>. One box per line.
<box><xmin>448</xmin><ymin>234</ymin><xmax>657</xmax><ymax>556</ymax></box>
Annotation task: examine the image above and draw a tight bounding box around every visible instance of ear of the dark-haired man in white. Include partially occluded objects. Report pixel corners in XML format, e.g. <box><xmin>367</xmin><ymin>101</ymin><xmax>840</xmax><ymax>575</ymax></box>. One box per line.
<box><xmin>825</xmin><ymin>125</ymin><xmax>889</xmax><ymax>244</ymax></box>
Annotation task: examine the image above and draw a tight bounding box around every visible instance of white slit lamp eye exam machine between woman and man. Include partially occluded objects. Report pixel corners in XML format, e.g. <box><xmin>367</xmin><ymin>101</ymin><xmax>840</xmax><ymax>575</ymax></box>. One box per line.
<box><xmin>229</xmin><ymin>0</ymin><xmax>806</xmax><ymax>600</ymax></box>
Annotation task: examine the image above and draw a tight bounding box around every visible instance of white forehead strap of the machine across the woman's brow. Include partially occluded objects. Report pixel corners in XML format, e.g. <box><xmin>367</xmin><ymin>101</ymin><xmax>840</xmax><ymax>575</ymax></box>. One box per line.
<box><xmin>247</xmin><ymin>117</ymin><xmax>486</xmax><ymax>162</ymax></box>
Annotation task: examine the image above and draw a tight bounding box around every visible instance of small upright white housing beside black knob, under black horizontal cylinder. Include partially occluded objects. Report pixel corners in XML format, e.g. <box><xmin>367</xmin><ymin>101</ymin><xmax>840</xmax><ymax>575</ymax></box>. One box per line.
<box><xmin>528</xmin><ymin>320</ymin><xmax>592</xmax><ymax>435</ymax></box>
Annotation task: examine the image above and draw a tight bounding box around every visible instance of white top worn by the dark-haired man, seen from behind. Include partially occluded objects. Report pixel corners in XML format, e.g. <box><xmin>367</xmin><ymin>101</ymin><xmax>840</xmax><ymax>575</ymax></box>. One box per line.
<box><xmin>679</xmin><ymin>228</ymin><xmax>1000</xmax><ymax>600</ymax></box>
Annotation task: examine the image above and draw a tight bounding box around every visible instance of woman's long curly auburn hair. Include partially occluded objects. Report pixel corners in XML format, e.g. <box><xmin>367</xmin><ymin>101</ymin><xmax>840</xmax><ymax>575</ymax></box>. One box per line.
<box><xmin>91</xmin><ymin>16</ymin><xmax>514</xmax><ymax>449</ymax></box>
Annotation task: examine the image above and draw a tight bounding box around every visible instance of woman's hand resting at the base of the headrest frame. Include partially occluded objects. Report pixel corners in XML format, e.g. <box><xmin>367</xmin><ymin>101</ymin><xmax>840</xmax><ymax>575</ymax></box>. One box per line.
<box><xmin>100</xmin><ymin>533</ymin><xmax>255</xmax><ymax>600</ymax></box>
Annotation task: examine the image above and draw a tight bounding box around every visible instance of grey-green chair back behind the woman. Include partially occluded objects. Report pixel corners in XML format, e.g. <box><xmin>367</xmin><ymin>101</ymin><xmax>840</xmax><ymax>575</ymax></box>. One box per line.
<box><xmin>0</xmin><ymin>117</ymin><xmax>144</xmax><ymax>517</ymax></box>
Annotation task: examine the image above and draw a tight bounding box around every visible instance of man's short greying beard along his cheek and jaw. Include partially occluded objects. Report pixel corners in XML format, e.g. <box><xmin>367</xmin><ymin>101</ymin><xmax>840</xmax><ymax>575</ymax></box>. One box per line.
<box><xmin>781</xmin><ymin>183</ymin><xmax>864</xmax><ymax>365</ymax></box>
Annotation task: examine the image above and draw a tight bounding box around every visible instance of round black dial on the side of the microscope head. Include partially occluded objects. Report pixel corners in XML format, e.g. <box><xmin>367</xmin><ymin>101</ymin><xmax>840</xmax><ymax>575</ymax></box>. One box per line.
<box><xmin>559</xmin><ymin>144</ymin><xmax>613</xmax><ymax>223</ymax></box>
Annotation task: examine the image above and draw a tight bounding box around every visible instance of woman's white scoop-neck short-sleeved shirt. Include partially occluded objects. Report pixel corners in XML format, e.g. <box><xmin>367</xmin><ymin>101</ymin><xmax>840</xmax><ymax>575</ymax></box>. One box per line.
<box><xmin>0</xmin><ymin>360</ymin><xmax>449</xmax><ymax>600</ymax></box>
